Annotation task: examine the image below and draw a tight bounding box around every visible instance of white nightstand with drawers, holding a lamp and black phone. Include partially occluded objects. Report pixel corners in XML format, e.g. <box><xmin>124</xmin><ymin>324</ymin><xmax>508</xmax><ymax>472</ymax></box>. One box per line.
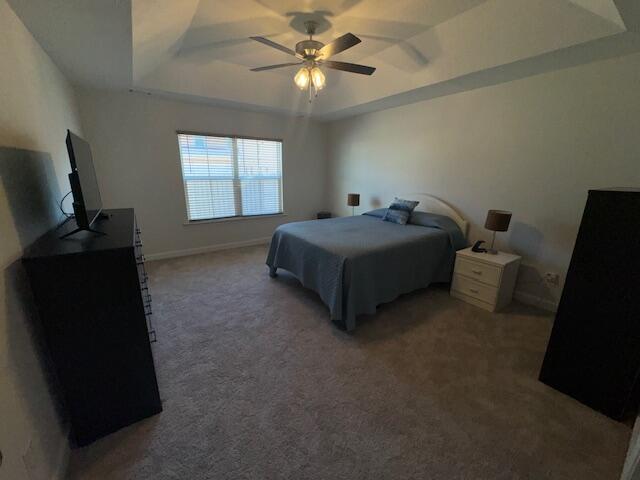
<box><xmin>451</xmin><ymin>248</ymin><xmax>521</xmax><ymax>312</ymax></box>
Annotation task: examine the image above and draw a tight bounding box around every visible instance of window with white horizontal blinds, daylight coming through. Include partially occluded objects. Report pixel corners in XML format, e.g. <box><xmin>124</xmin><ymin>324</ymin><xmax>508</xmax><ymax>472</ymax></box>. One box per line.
<box><xmin>178</xmin><ymin>132</ymin><xmax>282</xmax><ymax>221</ymax></box>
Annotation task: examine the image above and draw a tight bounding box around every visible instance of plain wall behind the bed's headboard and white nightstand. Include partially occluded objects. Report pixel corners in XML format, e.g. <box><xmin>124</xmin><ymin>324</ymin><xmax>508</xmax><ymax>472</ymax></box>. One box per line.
<box><xmin>328</xmin><ymin>51</ymin><xmax>640</xmax><ymax>307</ymax></box>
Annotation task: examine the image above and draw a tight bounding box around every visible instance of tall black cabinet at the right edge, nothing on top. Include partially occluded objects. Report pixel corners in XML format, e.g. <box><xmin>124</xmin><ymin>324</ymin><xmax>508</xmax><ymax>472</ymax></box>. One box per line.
<box><xmin>540</xmin><ymin>189</ymin><xmax>640</xmax><ymax>420</ymax></box>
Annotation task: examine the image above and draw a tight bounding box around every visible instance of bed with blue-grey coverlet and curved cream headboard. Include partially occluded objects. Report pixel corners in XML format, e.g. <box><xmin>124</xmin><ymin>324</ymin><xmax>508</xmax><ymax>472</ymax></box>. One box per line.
<box><xmin>266</xmin><ymin>194</ymin><xmax>468</xmax><ymax>331</ymax></box>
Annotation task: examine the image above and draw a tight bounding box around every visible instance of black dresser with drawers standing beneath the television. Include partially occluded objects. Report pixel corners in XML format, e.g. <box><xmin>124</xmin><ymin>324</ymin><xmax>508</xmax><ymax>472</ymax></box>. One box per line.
<box><xmin>23</xmin><ymin>209</ymin><xmax>162</xmax><ymax>446</ymax></box>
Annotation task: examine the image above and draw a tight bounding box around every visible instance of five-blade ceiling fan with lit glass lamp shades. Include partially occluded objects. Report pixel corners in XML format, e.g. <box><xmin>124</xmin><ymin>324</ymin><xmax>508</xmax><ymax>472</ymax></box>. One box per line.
<box><xmin>250</xmin><ymin>21</ymin><xmax>376</xmax><ymax>102</ymax></box>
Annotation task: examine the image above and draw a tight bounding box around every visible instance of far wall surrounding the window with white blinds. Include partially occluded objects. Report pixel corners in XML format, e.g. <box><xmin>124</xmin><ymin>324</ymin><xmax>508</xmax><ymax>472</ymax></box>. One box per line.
<box><xmin>79</xmin><ymin>90</ymin><xmax>326</xmax><ymax>256</ymax></box>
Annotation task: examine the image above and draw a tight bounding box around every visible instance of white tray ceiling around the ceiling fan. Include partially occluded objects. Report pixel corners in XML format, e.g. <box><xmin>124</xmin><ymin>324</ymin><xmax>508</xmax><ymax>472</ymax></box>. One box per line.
<box><xmin>9</xmin><ymin>0</ymin><xmax>640</xmax><ymax>119</ymax></box>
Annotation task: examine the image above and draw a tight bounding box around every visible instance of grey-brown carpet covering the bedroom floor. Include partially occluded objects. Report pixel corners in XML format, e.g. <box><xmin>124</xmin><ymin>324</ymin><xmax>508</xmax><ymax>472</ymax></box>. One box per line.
<box><xmin>70</xmin><ymin>247</ymin><xmax>630</xmax><ymax>480</ymax></box>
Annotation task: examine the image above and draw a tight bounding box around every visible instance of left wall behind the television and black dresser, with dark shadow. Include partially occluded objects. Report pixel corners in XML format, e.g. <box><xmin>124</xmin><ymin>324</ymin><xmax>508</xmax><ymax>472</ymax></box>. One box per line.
<box><xmin>0</xmin><ymin>0</ymin><xmax>80</xmax><ymax>480</ymax></box>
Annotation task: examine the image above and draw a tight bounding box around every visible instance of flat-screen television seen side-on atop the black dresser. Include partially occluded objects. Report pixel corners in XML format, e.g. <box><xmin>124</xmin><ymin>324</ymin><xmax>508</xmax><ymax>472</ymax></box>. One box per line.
<box><xmin>67</xmin><ymin>130</ymin><xmax>102</xmax><ymax>228</ymax></box>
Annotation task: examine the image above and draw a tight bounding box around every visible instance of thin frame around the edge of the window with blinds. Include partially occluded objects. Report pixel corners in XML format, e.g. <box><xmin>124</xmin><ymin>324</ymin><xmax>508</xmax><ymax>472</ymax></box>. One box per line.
<box><xmin>175</xmin><ymin>130</ymin><xmax>287</xmax><ymax>225</ymax></box>
